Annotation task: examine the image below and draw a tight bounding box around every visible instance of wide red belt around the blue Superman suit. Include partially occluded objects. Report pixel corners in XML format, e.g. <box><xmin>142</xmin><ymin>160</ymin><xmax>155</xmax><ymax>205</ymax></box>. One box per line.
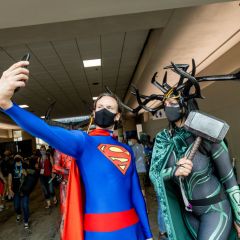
<box><xmin>84</xmin><ymin>208</ymin><xmax>139</xmax><ymax>232</ymax></box>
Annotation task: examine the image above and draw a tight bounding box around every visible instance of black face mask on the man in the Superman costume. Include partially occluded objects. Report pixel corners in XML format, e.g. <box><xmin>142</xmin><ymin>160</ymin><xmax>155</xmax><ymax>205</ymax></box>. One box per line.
<box><xmin>94</xmin><ymin>108</ymin><xmax>116</xmax><ymax>128</ymax></box>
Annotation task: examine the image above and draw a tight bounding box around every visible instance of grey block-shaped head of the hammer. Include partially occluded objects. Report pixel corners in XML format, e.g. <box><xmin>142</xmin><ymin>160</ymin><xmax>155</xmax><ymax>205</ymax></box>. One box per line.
<box><xmin>184</xmin><ymin>111</ymin><xmax>229</xmax><ymax>142</ymax></box>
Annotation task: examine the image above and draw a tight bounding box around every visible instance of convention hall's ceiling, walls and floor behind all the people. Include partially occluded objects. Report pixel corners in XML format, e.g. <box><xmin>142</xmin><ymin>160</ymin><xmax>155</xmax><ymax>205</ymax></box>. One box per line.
<box><xmin>0</xmin><ymin>0</ymin><xmax>240</xmax><ymax>240</ymax></box>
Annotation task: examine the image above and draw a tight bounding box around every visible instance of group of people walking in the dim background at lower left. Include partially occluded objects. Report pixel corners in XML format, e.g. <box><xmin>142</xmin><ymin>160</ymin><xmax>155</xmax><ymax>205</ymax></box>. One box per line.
<box><xmin>0</xmin><ymin>145</ymin><xmax>63</xmax><ymax>229</ymax></box>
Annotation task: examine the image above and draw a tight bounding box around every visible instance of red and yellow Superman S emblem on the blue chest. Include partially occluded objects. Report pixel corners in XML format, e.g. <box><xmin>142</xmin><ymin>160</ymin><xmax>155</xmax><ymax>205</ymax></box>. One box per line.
<box><xmin>98</xmin><ymin>144</ymin><xmax>131</xmax><ymax>174</ymax></box>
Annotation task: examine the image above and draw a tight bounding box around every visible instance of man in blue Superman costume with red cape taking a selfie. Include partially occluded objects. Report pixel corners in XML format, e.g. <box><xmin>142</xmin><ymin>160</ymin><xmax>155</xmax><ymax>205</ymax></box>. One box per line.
<box><xmin>0</xmin><ymin>61</ymin><xmax>152</xmax><ymax>240</ymax></box>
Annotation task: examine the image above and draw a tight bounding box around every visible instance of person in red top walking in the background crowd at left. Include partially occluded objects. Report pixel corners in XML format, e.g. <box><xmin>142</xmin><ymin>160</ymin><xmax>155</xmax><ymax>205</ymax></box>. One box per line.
<box><xmin>38</xmin><ymin>145</ymin><xmax>57</xmax><ymax>209</ymax></box>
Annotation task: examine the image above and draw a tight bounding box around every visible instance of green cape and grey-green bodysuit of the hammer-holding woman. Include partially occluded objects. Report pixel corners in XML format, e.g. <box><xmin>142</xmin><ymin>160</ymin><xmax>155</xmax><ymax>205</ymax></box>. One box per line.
<box><xmin>150</xmin><ymin>128</ymin><xmax>240</xmax><ymax>240</ymax></box>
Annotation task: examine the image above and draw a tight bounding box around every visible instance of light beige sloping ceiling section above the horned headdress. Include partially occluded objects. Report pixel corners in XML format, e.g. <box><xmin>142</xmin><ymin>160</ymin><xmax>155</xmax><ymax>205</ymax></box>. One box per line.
<box><xmin>125</xmin><ymin>2</ymin><xmax>240</xmax><ymax>109</ymax></box>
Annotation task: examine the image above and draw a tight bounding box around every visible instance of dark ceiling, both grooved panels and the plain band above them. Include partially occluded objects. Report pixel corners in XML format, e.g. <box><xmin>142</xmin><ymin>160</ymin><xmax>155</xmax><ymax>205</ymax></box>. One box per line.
<box><xmin>0</xmin><ymin>10</ymin><xmax>171</xmax><ymax>117</ymax></box>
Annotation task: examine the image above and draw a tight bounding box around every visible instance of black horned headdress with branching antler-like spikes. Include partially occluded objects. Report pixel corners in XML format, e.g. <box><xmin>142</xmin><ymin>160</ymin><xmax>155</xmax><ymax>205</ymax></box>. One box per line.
<box><xmin>112</xmin><ymin>59</ymin><xmax>240</xmax><ymax>114</ymax></box>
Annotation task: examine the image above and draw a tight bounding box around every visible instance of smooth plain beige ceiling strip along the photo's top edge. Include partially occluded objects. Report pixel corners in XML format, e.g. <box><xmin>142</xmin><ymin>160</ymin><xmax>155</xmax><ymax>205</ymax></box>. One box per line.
<box><xmin>0</xmin><ymin>0</ymin><xmax>232</xmax><ymax>28</ymax></box>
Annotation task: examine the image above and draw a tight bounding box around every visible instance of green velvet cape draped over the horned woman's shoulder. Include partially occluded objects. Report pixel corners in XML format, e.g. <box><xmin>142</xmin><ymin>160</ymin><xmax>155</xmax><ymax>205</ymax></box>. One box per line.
<box><xmin>149</xmin><ymin>128</ymin><xmax>237</xmax><ymax>240</ymax></box>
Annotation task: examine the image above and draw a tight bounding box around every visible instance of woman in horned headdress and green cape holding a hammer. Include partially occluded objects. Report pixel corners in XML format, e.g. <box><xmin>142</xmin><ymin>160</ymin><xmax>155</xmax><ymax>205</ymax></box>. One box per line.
<box><xmin>128</xmin><ymin>61</ymin><xmax>240</xmax><ymax>240</ymax></box>
